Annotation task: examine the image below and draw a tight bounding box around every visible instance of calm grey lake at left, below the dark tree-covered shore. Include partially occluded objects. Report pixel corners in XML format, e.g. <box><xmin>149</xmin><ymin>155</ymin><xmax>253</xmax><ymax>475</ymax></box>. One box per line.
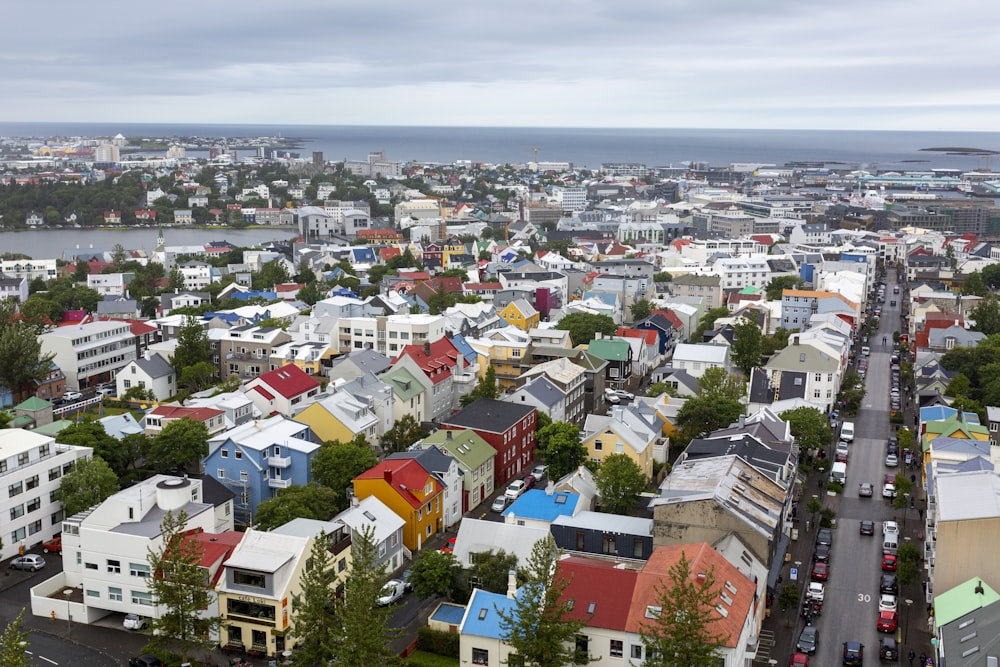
<box><xmin>0</xmin><ymin>227</ymin><xmax>298</xmax><ymax>259</ymax></box>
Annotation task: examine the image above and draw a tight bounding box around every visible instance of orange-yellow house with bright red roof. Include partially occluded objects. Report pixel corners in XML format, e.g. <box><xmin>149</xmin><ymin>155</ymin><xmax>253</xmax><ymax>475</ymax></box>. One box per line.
<box><xmin>354</xmin><ymin>459</ymin><xmax>444</xmax><ymax>551</ymax></box>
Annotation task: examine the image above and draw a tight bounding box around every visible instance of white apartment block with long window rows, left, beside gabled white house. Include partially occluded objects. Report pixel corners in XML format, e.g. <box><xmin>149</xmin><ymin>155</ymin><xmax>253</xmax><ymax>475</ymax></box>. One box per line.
<box><xmin>39</xmin><ymin>320</ymin><xmax>137</xmax><ymax>389</ymax></box>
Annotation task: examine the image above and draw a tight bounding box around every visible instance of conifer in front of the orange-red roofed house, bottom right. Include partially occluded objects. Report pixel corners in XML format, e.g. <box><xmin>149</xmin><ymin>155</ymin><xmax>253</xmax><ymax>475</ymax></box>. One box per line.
<box><xmin>642</xmin><ymin>552</ymin><xmax>726</xmax><ymax>667</ymax></box>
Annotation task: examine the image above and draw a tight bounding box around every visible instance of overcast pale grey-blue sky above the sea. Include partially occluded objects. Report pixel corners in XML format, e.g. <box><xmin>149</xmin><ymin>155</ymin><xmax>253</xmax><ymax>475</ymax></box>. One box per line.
<box><xmin>7</xmin><ymin>0</ymin><xmax>1000</xmax><ymax>131</ymax></box>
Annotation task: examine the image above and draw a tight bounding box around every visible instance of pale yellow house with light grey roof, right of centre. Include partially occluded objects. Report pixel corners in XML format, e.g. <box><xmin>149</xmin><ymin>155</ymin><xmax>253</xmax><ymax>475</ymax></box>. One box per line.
<box><xmin>583</xmin><ymin>406</ymin><xmax>659</xmax><ymax>480</ymax></box>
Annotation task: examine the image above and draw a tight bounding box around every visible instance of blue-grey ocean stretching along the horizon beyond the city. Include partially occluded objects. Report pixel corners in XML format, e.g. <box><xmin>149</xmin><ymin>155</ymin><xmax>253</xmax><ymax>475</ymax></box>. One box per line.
<box><xmin>0</xmin><ymin>123</ymin><xmax>1000</xmax><ymax>171</ymax></box>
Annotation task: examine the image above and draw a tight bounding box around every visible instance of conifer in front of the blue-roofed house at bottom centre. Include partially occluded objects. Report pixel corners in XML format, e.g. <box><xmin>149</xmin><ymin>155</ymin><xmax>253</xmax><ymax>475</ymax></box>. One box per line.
<box><xmin>497</xmin><ymin>535</ymin><xmax>590</xmax><ymax>667</ymax></box>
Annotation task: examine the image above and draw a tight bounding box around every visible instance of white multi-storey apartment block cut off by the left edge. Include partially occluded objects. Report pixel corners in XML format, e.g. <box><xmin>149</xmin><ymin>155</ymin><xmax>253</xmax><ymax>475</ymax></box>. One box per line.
<box><xmin>0</xmin><ymin>428</ymin><xmax>94</xmax><ymax>560</ymax></box>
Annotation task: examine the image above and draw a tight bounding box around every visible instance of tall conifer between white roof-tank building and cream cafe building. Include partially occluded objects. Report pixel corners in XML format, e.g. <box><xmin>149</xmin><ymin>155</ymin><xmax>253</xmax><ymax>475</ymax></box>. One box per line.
<box><xmin>146</xmin><ymin>510</ymin><xmax>222</xmax><ymax>662</ymax></box>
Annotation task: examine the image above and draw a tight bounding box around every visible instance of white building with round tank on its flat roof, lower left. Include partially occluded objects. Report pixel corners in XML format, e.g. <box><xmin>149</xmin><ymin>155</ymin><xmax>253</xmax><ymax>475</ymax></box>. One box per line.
<box><xmin>31</xmin><ymin>475</ymin><xmax>233</xmax><ymax>624</ymax></box>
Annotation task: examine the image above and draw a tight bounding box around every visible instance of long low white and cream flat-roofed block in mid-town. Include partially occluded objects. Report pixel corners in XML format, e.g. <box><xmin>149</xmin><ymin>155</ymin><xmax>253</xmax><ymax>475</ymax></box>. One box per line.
<box><xmin>337</xmin><ymin>313</ymin><xmax>447</xmax><ymax>359</ymax></box>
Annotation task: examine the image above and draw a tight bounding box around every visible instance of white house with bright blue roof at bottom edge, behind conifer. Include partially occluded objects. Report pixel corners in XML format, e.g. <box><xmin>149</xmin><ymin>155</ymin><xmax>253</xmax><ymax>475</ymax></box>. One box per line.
<box><xmin>459</xmin><ymin>586</ymin><xmax>516</xmax><ymax>667</ymax></box>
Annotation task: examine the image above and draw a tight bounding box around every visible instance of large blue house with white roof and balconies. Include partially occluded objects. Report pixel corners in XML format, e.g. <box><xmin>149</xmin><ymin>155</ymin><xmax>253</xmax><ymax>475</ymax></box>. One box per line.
<box><xmin>202</xmin><ymin>415</ymin><xmax>319</xmax><ymax>526</ymax></box>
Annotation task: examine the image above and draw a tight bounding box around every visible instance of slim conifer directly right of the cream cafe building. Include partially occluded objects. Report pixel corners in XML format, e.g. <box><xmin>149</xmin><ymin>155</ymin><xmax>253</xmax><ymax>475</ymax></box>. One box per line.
<box><xmin>288</xmin><ymin>533</ymin><xmax>340</xmax><ymax>667</ymax></box>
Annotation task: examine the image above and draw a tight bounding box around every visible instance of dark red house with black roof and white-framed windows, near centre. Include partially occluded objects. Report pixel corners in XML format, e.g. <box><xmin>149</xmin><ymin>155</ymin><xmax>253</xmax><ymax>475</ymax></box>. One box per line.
<box><xmin>441</xmin><ymin>398</ymin><xmax>538</xmax><ymax>489</ymax></box>
